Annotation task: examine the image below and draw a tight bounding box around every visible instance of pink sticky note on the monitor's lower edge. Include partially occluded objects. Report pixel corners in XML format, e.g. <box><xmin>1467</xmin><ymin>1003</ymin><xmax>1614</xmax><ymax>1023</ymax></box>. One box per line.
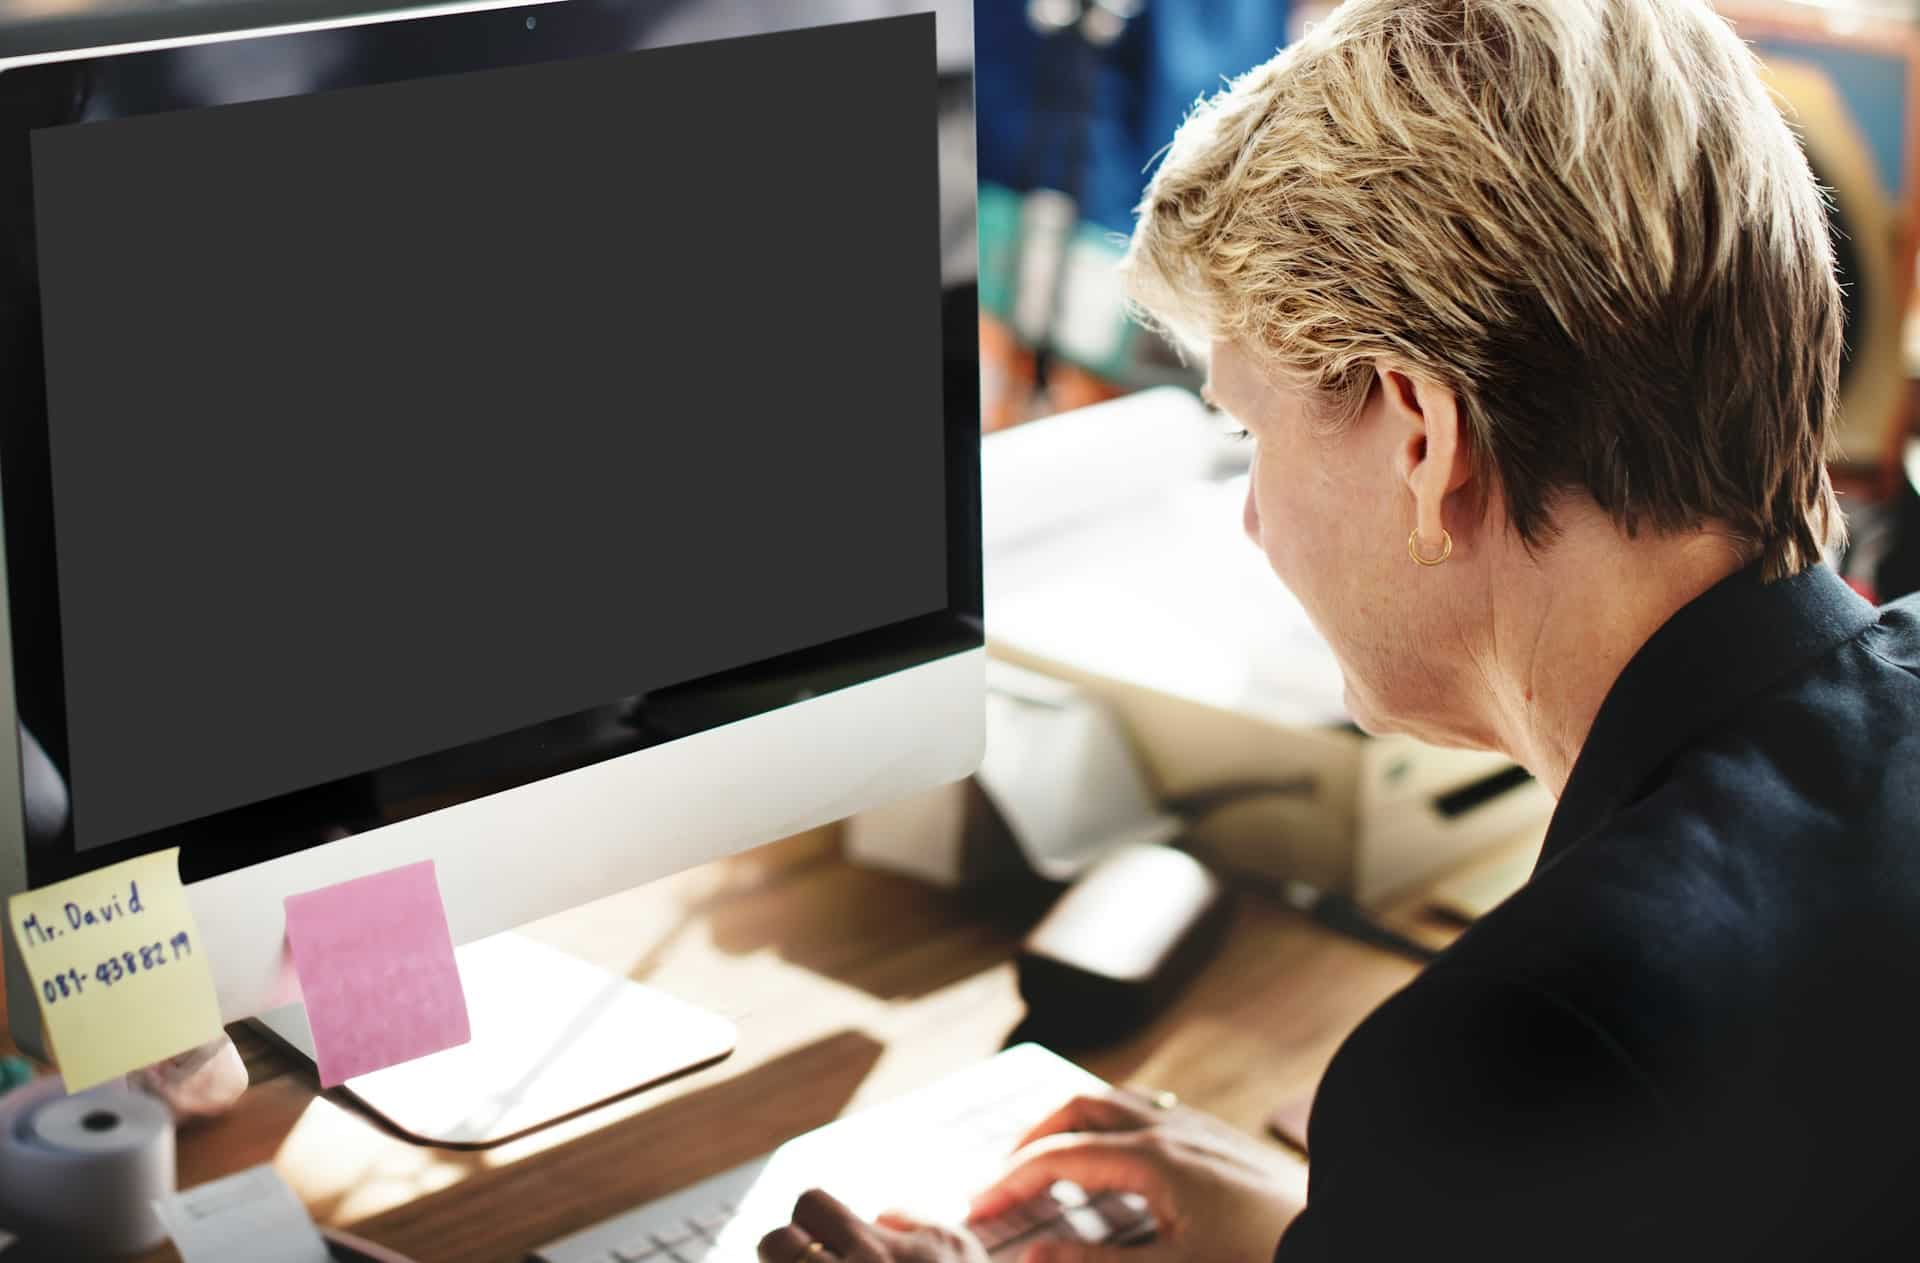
<box><xmin>286</xmin><ymin>860</ymin><xmax>472</xmax><ymax>1088</ymax></box>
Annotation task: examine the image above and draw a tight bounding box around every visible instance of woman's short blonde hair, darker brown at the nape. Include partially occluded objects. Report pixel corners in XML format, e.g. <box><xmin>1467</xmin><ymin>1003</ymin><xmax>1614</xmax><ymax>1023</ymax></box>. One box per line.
<box><xmin>1123</xmin><ymin>0</ymin><xmax>1841</xmax><ymax>578</ymax></box>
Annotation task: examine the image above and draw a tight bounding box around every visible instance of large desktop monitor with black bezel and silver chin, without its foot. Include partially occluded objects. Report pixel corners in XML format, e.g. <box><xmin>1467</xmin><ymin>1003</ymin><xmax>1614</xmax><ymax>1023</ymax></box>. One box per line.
<box><xmin>0</xmin><ymin>0</ymin><xmax>983</xmax><ymax>1090</ymax></box>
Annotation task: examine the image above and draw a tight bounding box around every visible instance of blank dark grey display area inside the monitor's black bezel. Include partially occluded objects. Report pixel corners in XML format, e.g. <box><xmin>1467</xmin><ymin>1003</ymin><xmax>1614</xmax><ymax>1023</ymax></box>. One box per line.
<box><xmin>33</xmin><ymin>15</ymin><xmax>947</xmax><ymax>848</ymax></box>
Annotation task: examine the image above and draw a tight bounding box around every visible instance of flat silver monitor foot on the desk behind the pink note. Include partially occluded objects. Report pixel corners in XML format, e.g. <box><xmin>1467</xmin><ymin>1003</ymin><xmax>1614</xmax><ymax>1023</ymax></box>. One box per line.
<box><xmin>257</xmin><ymin>933</ymin><xmax>735</xmax><ymax>1150</ymax></box>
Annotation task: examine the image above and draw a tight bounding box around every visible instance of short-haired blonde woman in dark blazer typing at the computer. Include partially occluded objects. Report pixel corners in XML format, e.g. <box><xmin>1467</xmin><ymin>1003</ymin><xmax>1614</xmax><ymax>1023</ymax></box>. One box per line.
<box><xmin>762</xmin><ymin>0</ymin><xmax>1920</xmax><ymax>1263</ymax></box>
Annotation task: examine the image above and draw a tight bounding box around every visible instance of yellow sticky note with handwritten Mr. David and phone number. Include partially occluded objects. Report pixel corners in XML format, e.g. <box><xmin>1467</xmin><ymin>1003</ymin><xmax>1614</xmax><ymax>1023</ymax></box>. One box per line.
<box><xmin>8</xmin><ymin>848</ymin><xmax>221</xmax><ymax>1092</ymax></box>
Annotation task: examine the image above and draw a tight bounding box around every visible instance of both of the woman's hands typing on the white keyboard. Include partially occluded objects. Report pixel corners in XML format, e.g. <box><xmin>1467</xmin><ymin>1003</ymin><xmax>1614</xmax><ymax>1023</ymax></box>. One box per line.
<box><xmin>760</xmin><ymin>1090</ymin><xmax>1304</xmax><ymax>1263</ymax></box>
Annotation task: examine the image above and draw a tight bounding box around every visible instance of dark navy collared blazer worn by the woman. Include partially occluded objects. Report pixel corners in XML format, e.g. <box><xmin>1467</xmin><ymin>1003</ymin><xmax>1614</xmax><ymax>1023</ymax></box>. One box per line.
<box><xmin>1279</xmin><ymin>566</ymin><xmax>1920</xmax><ymax>1263</ymax></box>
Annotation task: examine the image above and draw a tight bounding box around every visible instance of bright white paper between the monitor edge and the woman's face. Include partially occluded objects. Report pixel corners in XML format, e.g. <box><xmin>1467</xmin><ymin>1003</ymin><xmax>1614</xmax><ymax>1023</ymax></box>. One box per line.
<box><xmin>981</xmin><ymin>388</ymin><xmax>1346</xmax><ymax>726</ymax></box>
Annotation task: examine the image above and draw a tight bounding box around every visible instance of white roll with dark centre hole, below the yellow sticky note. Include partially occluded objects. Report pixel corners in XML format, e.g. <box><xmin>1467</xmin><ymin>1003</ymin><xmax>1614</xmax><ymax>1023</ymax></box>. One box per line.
<box><xmin>0</xmin><ymin>1079</ymin><xmax>175</xmax><ymax>1255</ymax></box>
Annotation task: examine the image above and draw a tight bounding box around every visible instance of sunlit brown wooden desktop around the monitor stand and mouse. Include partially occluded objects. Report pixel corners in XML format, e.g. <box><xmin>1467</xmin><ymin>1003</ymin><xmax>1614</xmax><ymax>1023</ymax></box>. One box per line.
<box><xmin>0</xmin><ymin>831</ymin><xmax>1443</xmax><ymax>1263</ymax></box>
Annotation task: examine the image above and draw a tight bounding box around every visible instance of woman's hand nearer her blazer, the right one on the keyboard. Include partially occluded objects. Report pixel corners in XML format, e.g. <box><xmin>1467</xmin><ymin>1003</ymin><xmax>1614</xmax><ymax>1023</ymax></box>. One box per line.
<box><xmin>972</xmin><ymin>1090</ymin><xmax>1306</xmax><ymax>1263</ymax></box>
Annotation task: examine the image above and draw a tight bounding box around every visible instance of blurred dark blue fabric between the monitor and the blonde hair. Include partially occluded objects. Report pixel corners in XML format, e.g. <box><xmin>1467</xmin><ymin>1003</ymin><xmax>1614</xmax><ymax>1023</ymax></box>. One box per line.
<box><xmin>973</xmin><ymin>0</ymin><xmax>1288</xmax><ymax>232</ymax></box>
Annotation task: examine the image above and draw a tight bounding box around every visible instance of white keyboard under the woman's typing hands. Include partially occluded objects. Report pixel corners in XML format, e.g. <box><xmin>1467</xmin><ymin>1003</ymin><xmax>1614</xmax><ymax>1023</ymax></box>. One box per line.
<box><xmin>532</xmin><ymin>1044</ymin><xmax>1154</xmax><ymax>1263</ymax></box>
